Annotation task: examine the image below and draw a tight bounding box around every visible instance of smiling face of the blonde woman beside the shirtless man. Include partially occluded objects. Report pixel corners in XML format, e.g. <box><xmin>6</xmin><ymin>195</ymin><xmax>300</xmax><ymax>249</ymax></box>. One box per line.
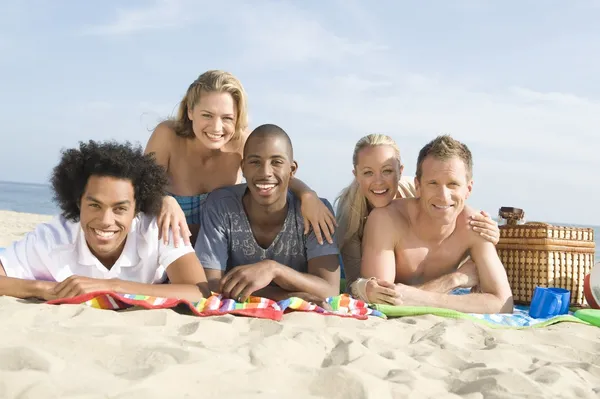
<box><xmin>353</xmin><ymin>145</ymin><xmax>403</xmax><ymax>208</ymax></box>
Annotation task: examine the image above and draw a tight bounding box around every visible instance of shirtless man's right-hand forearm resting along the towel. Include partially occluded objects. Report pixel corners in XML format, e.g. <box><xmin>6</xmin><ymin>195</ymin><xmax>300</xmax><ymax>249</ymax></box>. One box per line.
<box><xmin>403</xmin><ymin>290</ymin><xmax>513</xmax><ymax>313</ymax></box>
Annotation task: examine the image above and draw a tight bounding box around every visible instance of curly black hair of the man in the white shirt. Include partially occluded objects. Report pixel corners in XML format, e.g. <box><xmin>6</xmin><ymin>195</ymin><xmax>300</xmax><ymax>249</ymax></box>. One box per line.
<box><xmin>50</xmin><ymin>140</ymin><xmax>168</xmax><ymax>222</ymax></box>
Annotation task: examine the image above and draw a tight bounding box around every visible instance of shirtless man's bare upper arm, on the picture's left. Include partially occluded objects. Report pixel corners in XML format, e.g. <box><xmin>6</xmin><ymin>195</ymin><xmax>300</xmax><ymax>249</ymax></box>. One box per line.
<box><xmin>360</xmin><ymin>206</ymin><xmax>398</xmax><ymax>283</ymax></box>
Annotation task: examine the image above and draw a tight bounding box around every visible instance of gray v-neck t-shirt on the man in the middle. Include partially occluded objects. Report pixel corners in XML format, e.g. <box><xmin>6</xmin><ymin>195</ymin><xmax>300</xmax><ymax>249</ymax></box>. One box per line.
<box><xmin>195</xmin><ymin>184</ymin><xmax>339</xmax><ymax>273</ymax></box>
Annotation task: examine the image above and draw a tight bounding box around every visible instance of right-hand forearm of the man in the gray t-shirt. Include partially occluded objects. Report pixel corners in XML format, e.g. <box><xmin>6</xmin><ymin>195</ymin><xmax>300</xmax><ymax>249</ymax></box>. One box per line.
<box><xmin>273</xmin><ymin>264</ymin><xmax>340</xmax><ymax>298</ymax></box>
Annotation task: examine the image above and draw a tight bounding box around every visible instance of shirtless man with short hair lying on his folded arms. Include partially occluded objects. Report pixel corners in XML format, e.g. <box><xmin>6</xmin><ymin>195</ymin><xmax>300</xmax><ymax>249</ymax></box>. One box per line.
<box><xmin>354</xmin><ymin>136</ymin><xmax>513</xmax><ymax>313</ymax></box>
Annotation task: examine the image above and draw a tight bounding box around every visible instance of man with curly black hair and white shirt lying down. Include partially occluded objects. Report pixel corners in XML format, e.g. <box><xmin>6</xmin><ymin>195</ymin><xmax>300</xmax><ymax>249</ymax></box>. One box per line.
<box><xmin>0</xmin><ymin>141</ymin><xmax>209</xmax><ymax>301</ymax></box>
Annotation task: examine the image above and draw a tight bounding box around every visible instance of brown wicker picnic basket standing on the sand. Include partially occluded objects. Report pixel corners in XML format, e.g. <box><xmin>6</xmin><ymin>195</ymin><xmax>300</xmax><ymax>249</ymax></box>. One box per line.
<box><xmin>496</xmin><ymin>207</ymin><xmax>596</xmax><ymax>306</ymax></box>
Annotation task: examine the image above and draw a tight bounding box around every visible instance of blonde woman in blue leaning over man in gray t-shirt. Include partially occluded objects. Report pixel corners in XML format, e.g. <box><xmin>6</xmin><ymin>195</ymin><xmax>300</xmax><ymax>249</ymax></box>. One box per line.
<box><xmin>146</xmin><ymin>70</ymin><xmax>336</xmax><ymax>244</ymax></box>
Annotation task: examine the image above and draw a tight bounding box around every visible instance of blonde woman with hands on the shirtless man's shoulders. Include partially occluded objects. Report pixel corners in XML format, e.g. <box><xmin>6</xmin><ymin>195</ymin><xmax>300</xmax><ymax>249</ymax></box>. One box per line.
<box><xmin>336</xmin><ymin>134</ymin><xmax>500</xmax><ymax>292</ymax></box>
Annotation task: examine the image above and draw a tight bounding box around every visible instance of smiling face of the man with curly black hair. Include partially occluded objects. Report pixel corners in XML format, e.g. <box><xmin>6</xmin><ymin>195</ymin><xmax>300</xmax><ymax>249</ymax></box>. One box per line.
<box><xmin>79</xmin><ymin>176</ymin><xmax>135</xmax><ymax>265</ymax></box>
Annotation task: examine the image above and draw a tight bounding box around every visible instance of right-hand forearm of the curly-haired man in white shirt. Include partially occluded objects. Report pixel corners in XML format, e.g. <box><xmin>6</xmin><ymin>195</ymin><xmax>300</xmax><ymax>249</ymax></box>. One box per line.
<box><xmin>112</xmin><ymin>279</ymin><xmax>210</xmax><ymax>302</ymax></box>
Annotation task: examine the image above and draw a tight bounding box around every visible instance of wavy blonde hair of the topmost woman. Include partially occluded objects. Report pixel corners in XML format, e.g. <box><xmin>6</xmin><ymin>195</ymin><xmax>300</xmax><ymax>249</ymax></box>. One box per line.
<box><xmin>174</xmin><ymin>70</ymin><xmax>248</xmax><ymax>140</ymax></box>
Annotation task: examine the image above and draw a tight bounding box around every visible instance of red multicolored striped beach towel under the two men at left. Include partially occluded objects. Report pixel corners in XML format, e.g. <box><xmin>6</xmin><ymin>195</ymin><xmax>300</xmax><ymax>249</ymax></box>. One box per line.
<box><xmin>47</xmin><ymin>291</ymin><xmax>386</xmax><ymax>320</ymax></box>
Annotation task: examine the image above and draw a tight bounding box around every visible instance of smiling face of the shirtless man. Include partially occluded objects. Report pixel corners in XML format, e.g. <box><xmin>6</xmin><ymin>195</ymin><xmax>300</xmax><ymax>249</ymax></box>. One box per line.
<box><xmin>415</xmin><ymin>156</ymin><xmax>473</xmax><ymax>225</ymax></box>
